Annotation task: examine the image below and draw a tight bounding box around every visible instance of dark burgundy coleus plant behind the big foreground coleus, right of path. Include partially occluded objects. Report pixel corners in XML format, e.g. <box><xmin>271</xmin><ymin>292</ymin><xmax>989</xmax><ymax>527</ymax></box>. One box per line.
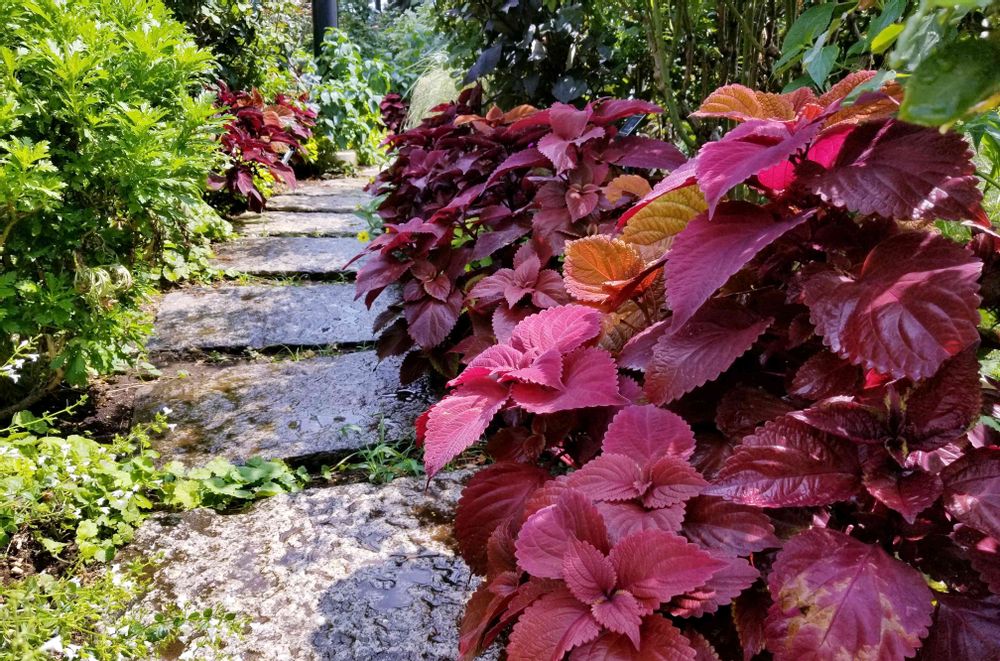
<box><xmin>348</xmin><ymin>88</ymin><xmax>683</xmax><ymax>377</ymax></box>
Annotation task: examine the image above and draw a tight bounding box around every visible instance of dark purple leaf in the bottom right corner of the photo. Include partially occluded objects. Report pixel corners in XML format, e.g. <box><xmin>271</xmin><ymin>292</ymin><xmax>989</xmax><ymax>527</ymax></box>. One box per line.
<box><xmin>920</xmin><ymin>594</ymin><xmax>1000</xmax><ymax>661</ymax></box>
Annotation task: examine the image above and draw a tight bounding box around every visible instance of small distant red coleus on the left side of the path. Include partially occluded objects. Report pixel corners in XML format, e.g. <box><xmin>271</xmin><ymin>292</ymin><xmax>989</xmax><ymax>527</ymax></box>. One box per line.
<box><xmin>208</xmin><ymin>81</ymin><xmax>316</xmax><ymax>212</ymax></box>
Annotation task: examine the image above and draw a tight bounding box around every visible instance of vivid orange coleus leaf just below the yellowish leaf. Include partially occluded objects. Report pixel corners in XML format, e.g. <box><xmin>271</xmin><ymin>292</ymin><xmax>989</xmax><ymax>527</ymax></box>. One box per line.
<box><xmin>563</xmin><ymin>235</ymin><xmax>656</xmax><ymax>305</ymax></box>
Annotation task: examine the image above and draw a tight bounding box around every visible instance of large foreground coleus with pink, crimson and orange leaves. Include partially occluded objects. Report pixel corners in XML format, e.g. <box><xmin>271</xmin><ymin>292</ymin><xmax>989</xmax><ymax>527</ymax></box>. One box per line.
<box><xmin>418</xmin><ymin>72</ymin><xmax>1000</xmax><ymax>661</ymax></box>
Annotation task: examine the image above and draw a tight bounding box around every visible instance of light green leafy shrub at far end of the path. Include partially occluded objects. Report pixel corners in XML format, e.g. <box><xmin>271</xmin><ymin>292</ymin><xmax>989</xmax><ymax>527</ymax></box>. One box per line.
<box><xmin>311</xmin><ymin>29</ymin><xmax>391</xmax><ymax>165</ymax></box>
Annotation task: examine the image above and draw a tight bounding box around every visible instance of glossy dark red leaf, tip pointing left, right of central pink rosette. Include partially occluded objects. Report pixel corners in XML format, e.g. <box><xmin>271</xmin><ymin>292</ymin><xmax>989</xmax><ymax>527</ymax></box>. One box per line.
<box><xmin>705</xmin><ymin>416</ymin><xmax>861</xmax><ymax>507</ymax></box>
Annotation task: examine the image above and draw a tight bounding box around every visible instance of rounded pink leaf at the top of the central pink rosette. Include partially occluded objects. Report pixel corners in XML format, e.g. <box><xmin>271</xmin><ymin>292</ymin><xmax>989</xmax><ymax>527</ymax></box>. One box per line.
<box><xmin>601</xmin><ymin>405</ymin><xmax>694</xmax><ymax>464</ymax></box>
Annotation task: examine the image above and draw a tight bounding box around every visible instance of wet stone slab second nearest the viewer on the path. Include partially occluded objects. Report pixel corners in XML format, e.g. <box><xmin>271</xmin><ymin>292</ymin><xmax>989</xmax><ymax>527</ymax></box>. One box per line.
<box><xmin>135</xmin><ymin>351</ymin><xmax>430</xmax><ymax>465</ymax></box>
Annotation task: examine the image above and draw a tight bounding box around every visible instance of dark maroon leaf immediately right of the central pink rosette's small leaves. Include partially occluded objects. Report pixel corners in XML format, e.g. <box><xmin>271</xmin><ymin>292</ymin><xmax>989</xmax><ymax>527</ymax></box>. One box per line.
<box><xmin>681</xmin><ymin>496</ymin><xmax>780</xmax><ymax>555</ymax></box>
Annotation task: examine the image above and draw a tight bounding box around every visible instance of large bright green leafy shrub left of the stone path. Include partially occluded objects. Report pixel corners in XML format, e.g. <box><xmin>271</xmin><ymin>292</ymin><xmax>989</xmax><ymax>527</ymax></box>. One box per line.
<box><xmin>0</xmin><ymin>0</ymin><xmax>220</xmax><ymax>404</ymax></box>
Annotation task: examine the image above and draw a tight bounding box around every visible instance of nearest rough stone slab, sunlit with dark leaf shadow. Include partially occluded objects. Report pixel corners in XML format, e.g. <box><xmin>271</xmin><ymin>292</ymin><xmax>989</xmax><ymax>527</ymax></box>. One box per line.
<box><xmin>126</xmin><ymin>473</ymin><xmax>496</xmax><ymax>661</ymax></box>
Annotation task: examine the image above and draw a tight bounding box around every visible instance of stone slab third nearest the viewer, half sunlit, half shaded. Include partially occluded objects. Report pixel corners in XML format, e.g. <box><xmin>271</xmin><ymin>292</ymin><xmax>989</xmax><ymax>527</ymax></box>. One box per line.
<box><xmin>148</xmin><ymin>284</ymin><xmax>387</xmax><ymax>351</ymax></box>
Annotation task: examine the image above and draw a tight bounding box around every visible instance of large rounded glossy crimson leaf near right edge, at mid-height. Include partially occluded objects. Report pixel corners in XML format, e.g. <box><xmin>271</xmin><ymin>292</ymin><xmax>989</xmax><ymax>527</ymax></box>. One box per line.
<box><xmin>804</xmin><ymin>232</ymin><xmax>982</xmax><ymax>379</ymax></box>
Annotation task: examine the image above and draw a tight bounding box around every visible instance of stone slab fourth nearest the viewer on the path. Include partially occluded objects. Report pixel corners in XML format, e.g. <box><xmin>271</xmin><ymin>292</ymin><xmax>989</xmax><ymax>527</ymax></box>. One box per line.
<box><xmin>212</xmin><ymin>236</ymin><xmax>364</xmax><ymax>275</ymax></box>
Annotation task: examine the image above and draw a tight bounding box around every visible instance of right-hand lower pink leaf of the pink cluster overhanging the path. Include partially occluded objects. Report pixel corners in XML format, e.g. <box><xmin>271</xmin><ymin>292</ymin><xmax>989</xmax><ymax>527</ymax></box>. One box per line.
<box><xmin>511</xmin><ymin>346</ymin><xmax>628</xmax><ymax>413</ymax></box>
